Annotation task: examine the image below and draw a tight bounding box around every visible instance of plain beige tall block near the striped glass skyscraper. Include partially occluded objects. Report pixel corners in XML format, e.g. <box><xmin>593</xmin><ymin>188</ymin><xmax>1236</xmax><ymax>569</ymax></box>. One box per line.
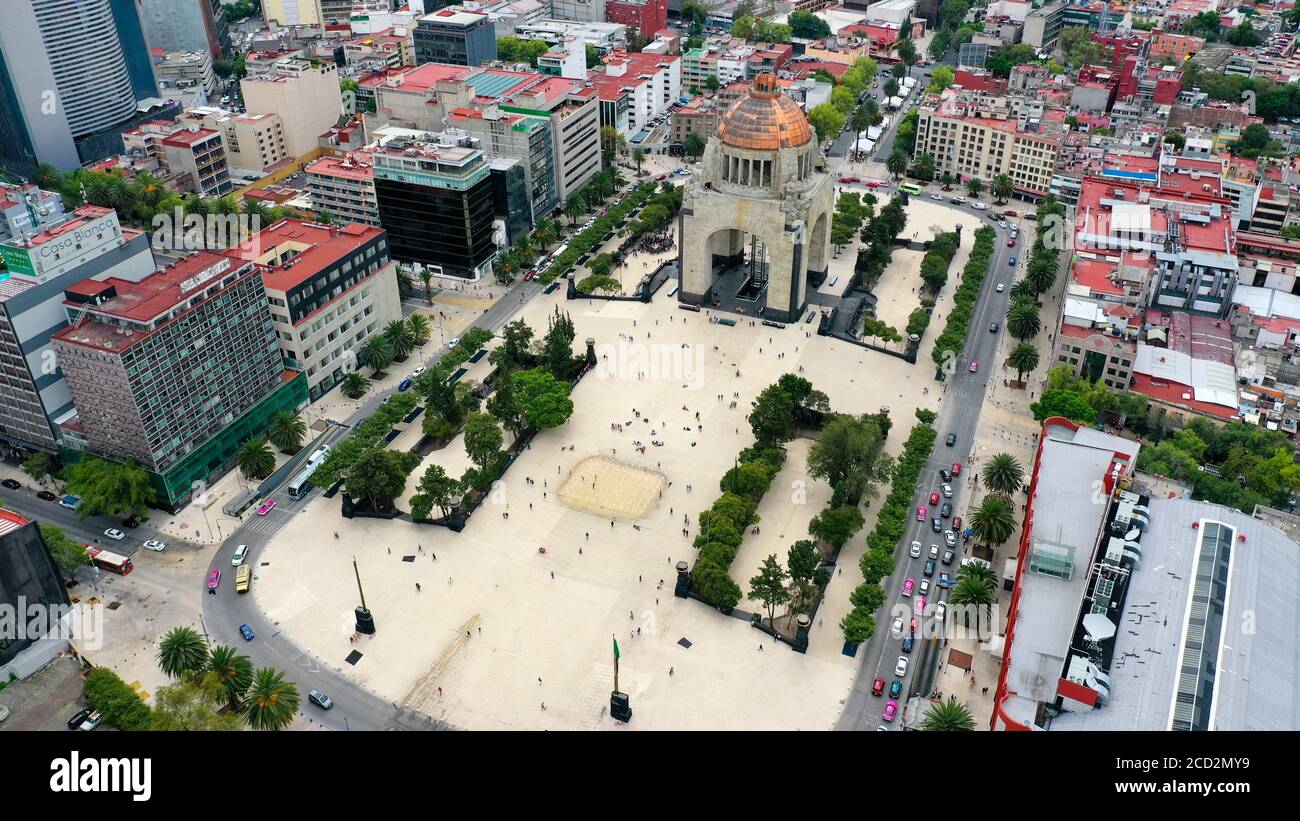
<box><xmin>239</xmin><ymin>58</ymin><xmax>343</xmax><ymax>158</ymax></box>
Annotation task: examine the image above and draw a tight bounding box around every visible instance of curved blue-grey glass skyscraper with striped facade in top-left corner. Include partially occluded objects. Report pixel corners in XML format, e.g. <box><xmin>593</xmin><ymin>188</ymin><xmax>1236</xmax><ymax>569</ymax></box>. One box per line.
<box><xmin>0</xmin><ymin>0</ymin><xmax>139</xmax><ymax>174</ymax></box>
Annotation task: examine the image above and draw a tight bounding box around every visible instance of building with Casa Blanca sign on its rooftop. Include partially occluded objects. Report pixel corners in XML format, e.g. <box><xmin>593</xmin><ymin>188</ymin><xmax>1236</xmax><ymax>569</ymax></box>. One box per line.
<box><xmin>0</xmin><ymin>205</ymin><xmax>157</xmax><ymax>455</ymax></box>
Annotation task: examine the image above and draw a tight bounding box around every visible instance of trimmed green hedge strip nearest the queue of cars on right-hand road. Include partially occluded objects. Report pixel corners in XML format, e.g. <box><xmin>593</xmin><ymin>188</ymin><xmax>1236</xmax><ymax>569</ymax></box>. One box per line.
<box><xmin>840</xmin><ymin>420</ymin><xmax>935</xmax><ymax>644</ymax></box>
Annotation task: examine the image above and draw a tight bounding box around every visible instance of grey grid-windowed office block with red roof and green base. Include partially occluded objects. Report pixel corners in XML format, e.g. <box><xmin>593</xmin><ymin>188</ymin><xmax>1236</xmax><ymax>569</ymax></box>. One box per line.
<box><xmin>53</xmin><ymin>251</ymin><xmax>307</xmax><ymax>509</ymax></box>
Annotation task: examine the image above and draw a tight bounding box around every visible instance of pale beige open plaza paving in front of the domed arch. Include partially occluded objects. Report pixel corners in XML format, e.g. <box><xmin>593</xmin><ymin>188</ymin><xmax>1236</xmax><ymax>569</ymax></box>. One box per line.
<box><xmin>254</xmin><ymin>214</ymin><xmax>969</xmax><ymax>729</ymax></box>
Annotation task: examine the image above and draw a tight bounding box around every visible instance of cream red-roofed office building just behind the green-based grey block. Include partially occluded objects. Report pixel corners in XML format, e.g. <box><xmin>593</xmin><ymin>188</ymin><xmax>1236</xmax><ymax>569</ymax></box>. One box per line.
<box><xmin>228</xmin><ymin>220</ymin><xmax>402</xmax><ymax>401</ymax></box>
